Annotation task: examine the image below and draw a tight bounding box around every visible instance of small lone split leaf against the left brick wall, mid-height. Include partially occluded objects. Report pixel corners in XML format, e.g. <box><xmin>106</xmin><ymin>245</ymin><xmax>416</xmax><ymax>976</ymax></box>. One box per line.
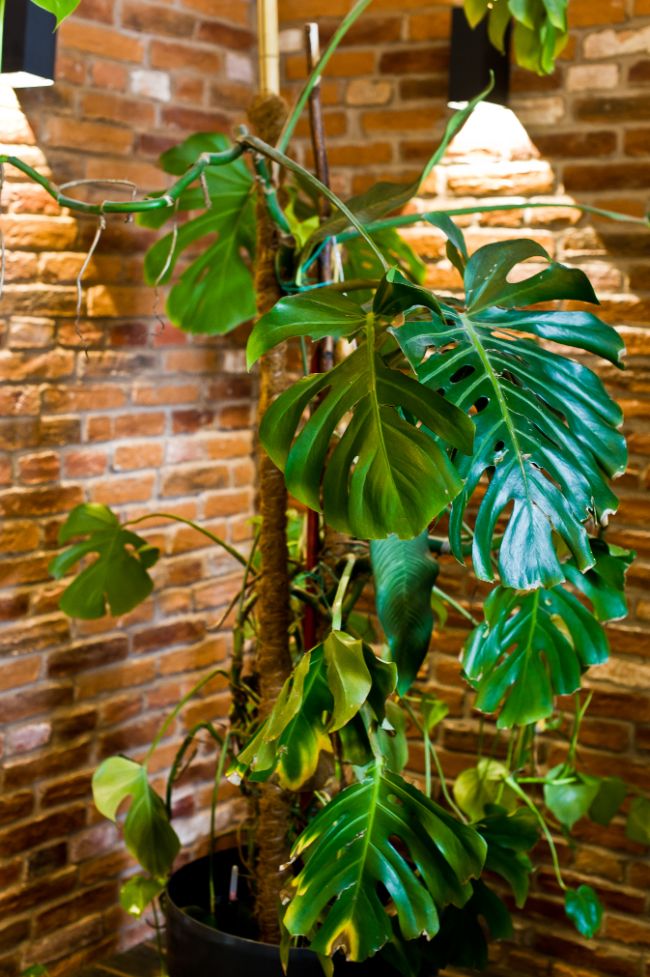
<box><xmin>49</xmin><ymin>503</ymin><xmax>159</xmax><ymax>619</ymax></box>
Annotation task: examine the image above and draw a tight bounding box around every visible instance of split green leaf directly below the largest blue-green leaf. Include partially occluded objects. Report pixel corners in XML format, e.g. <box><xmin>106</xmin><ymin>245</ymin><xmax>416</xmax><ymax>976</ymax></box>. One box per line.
<box><xmin>462</xmin><ymin>587</ymin><xmax>609</xmax><ymax>728</ymax></box>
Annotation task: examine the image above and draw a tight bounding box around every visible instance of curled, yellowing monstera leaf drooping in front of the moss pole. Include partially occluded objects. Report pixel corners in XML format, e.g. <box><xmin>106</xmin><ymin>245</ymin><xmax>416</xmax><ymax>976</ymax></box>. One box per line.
<box><xmin>227</xmin><ymin>631</ymin><xmax>395</xmax><ymax>790</ymax></box>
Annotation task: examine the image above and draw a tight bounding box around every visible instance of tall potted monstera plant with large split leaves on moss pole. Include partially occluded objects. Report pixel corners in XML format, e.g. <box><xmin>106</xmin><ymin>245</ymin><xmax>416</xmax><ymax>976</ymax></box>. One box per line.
<box><xmin>4</xmin><ymin>0</ymin><xmax>650</xmax><ymax>974</ymax></box>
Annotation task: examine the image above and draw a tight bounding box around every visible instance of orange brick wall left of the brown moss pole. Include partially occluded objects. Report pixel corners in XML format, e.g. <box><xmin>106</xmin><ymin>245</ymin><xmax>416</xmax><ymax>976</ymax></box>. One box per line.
<box><xmin>0</xmin><ymin>0</ymin><xmax>254</xmax><ymax>977</ymax></box>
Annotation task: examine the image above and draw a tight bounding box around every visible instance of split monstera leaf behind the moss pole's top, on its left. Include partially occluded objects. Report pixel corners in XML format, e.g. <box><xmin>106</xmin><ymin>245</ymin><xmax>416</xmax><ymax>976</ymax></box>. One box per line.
<box><xmin>142</xmin><ymin>133</ymin><xmax>255</xmax><ymax>333</ymax></box>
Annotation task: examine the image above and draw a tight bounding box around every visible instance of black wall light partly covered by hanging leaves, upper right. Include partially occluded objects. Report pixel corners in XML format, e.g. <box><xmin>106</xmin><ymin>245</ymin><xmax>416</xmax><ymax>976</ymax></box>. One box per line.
<box><xmin>449</xmin><ymin>6</ymin><xmax>510</xmax><ymax>105</ymax></box>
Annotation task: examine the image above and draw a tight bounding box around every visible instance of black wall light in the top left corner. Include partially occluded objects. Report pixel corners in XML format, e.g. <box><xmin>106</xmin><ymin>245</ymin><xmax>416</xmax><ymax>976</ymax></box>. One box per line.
<box><xmin>0</xmin><ymin>0</ymin><xmax>56</xmax><ymax>88</ymax></box>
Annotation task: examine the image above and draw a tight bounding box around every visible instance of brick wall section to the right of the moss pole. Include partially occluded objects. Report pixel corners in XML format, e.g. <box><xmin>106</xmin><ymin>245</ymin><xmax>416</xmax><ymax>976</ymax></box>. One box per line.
<box><xmin>280</xmin><ymin>0</ymin><xmax>650</xmax><ymax>977</ymax></box>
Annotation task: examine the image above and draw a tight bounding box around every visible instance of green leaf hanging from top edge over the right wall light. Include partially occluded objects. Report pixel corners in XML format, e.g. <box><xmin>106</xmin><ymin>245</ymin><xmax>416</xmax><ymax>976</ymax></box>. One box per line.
<box><xmin>464</xmin><ymin>0</ymin><xmax>569</xmax><ymax>75</ymax></box>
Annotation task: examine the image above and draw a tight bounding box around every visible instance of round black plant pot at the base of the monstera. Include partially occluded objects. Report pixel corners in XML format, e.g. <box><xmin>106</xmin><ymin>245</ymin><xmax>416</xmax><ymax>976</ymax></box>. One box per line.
<box><xmin>166</xmin><ymin>849</ymin><xmax>412</xmax><ymax>977</ymax></box>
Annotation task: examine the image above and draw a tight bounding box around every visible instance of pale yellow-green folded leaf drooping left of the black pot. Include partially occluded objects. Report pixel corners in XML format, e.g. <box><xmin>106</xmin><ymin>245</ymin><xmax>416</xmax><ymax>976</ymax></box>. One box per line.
<box><xmin>92</xmin><ymin>756</ymin><xmax>181</xmax><ymax>879</ymax></box>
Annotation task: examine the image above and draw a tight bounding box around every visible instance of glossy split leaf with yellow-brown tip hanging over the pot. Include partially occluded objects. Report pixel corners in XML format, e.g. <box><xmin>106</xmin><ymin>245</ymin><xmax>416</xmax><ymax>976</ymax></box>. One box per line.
<box><xmin>283</xmin><ymin>765</ymin><xmax>486</xmax><ymax>961</ymax></box>
